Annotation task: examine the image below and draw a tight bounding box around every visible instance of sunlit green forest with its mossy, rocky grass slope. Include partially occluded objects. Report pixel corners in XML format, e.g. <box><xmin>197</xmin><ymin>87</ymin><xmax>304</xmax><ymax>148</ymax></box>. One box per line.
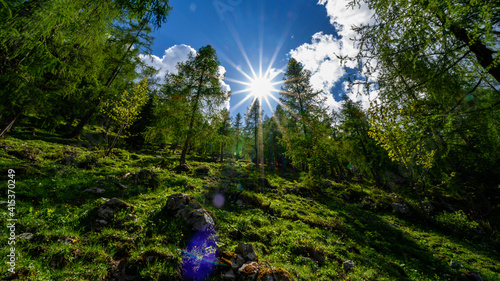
<box><xmin>0</xmin><ymin>0</ymin><xmax>500</xmax><ymax>281</ymax></box>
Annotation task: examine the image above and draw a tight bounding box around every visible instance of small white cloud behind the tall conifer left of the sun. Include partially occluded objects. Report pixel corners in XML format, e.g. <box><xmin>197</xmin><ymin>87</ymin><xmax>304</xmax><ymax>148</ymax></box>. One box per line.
<box><xmin>139</xmin><ymin>44</ymin><xmax>196</xmax><ymax>82</ymax></box>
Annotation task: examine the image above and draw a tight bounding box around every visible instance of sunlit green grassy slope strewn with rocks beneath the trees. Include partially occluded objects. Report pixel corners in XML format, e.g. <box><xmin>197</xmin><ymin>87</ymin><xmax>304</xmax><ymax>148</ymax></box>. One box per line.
<box><xmin>0</xmin><ymin>132</ymin><xmax>500</xmax><ymax>280</ymax></box>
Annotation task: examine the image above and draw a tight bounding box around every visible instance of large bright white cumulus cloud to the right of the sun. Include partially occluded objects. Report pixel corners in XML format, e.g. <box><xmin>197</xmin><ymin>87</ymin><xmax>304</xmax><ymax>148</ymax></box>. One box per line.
<box><xmin>290</xmin><ymin>0</ymin><xmax>375</xmax><ymax>108</ymax></box>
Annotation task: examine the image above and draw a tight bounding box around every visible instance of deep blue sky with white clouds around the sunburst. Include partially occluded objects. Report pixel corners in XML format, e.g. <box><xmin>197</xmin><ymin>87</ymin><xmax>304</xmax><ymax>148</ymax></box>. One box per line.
<box><xmin>141</xmin><ymin>0</ymin><xmax>376</xmax><ymax>116</ymax></box>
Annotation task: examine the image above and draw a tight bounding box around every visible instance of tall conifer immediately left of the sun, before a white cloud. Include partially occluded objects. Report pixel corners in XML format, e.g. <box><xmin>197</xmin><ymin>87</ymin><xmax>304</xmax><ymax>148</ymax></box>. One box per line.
<box><xmin>149</xmin><ymin>45</ymin><xmax>230</xmax><ymax>166</ymax></box>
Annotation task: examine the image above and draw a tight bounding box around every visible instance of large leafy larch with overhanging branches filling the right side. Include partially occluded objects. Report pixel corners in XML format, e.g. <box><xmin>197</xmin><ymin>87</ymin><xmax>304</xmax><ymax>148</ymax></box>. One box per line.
<box><xmin>353</xmin><ymin>0</ymin><xmax>500</xmax><ymax>197</ymax></box>
